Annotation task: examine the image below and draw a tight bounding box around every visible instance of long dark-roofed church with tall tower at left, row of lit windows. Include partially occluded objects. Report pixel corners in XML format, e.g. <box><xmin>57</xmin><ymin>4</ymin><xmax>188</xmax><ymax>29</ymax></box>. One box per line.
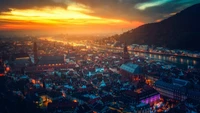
<box><xmin>25</xmin><ymin>42</ymin><xmax>75</xmax><ymax>72</ymax></box>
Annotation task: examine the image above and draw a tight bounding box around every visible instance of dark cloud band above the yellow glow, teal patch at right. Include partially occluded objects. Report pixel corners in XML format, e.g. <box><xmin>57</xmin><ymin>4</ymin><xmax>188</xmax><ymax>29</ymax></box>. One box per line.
<box><xmin>0</xmin><ymin>0</ymin><xmax>200</xmax><ymax>22</ymax></box>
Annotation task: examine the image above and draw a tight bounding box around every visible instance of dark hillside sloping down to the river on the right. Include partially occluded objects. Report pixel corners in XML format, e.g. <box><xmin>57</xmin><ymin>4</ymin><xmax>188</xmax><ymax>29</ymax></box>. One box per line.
<box><xmin>116</xmin><ymin>4</ymin><xmax>200</xmax><ymax>51</ymax></box>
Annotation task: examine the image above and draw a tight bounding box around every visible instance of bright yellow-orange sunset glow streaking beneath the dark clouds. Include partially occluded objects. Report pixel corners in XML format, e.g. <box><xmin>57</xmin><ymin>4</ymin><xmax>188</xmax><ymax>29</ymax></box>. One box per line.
<box><xmin>0</xmin><ymin>5</ymin><xmax>143</xmax><ymax>33</ymax></box>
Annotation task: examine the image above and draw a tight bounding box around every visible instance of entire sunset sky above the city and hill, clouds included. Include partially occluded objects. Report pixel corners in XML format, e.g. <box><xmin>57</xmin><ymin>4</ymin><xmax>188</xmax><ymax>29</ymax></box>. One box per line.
<box><xmin>0</xmin><ymin>0</ymin><xmax>200</xmax><ymax>34</ymax></box>
